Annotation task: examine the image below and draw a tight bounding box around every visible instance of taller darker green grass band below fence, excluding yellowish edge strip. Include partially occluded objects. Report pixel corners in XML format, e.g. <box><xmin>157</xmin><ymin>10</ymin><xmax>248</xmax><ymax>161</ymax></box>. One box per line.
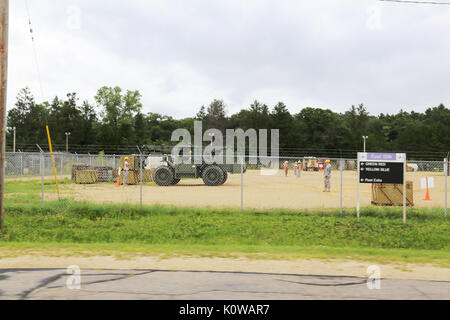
<box><xmin>0</xmin><ymin>200</ymin><xmax>449</xmax><ymax>250</ymax></box>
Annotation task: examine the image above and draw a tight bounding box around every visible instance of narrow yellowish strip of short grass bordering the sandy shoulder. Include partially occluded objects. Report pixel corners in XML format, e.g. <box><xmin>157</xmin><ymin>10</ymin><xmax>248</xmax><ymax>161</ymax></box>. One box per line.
<box><xmin>0</xmin><ymin>242</ymin><xmax>450</xmax><ymax>268</ymax></box>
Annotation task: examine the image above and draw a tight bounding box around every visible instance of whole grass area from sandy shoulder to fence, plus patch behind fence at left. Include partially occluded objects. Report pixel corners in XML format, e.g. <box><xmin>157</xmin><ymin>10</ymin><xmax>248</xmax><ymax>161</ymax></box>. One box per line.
<box><xmin>0</xmin><ymin>181</ymin><xmax>450</xmax><ymax>267</ymax></box>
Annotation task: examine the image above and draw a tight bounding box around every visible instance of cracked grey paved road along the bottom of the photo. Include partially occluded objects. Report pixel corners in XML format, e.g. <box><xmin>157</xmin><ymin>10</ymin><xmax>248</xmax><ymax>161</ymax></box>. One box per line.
<box><xmin>0</xmin><ymin>269</ymin><xmax>450</xmax><ymax>300</ymax></box>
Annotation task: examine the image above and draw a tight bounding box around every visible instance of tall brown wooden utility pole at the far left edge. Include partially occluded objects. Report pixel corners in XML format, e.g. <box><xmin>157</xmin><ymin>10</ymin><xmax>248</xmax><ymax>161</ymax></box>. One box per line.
<box><xmin>0</xmin><ymin>0</ymin><xmax>9</xmax><ymax>231</ymax></box>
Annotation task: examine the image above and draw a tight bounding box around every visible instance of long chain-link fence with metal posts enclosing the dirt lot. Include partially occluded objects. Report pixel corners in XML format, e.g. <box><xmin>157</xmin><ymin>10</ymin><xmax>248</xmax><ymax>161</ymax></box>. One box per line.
<box><xmin>5</xmin><ymin>152</ymin><xmax>449</xmax><ymax>218</ymax></box>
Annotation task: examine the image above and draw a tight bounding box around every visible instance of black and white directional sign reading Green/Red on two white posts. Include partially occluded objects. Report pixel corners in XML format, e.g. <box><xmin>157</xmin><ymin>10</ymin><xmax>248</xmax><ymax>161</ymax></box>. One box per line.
<box><xmin>356</xmin><ymin>152</ymin><xmax>406</xmax><ymax>223</ymax></box>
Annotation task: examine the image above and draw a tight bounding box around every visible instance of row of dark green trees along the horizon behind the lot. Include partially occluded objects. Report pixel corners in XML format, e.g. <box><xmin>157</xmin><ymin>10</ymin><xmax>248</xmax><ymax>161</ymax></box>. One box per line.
<box><xmin>7</xmin><ymin>87</ymin><xmax>450</xmax><ymax>159</ymax></box>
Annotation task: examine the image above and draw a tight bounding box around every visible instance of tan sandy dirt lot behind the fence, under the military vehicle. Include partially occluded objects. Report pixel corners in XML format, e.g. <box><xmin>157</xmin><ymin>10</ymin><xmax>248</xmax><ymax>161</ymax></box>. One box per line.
<box><xmin>58</xmin><ymin>170</ymin><xmax>444</xmax><ymax>209</ymax></box>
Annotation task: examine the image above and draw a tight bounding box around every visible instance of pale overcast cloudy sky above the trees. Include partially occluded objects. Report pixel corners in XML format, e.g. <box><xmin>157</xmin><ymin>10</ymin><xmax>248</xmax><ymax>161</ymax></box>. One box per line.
<box><xmin>8</xmin><ymin>0</ymin><xmax>450</xmax><ymax>118</ymax></box>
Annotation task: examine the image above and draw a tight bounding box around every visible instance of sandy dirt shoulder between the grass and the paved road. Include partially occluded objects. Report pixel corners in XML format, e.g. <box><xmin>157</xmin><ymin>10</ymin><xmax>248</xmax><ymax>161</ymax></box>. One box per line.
<box><xmin>0</xmin><ymin>255</ymin><xmax>450</xmax><ymax>281</ymax></box>
